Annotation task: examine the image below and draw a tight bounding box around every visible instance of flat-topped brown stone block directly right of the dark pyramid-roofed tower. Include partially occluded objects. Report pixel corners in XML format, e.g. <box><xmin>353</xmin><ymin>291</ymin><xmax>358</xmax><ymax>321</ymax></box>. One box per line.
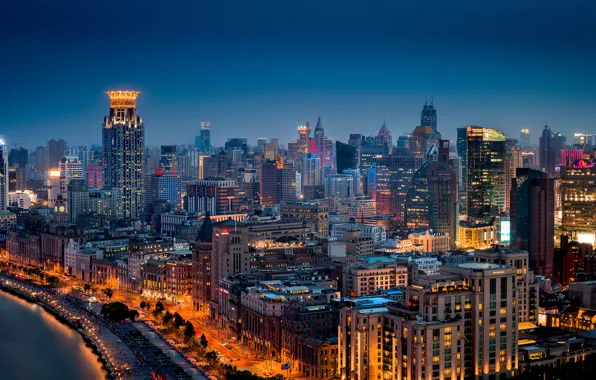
<box><xmin>211</xmin><ymin>219</ymin><xmax>250</xmax><ymax>304</ymax></box>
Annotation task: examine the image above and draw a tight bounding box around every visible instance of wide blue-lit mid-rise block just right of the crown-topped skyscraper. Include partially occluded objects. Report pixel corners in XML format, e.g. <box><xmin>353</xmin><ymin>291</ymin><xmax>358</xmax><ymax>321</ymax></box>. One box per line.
<box><xmin>144</xmin><ymin>169</ymin><xmax>182</xmax><ymax>210</ymax></box>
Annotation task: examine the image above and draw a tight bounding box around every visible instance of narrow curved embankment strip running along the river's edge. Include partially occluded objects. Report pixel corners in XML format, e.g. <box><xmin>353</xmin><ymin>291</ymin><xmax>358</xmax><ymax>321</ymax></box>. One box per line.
<box><xmin>0</xmin><ymin>281</ymin><xmax>114</xmax><ymax>380</ymax></box>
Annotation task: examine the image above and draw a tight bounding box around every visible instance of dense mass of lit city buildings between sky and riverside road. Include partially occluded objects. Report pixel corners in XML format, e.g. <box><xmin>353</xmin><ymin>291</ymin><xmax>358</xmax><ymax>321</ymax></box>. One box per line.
<box><xmin>0</xmin><ymin>91</ymin><xmax>596</xmax><ymax>380</ymax></box>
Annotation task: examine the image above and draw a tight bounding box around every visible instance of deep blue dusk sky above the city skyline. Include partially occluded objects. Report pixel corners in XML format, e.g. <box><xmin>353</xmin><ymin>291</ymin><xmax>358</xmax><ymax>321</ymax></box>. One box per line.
<box><xmin>0</xmin><ymin>0</ymin><xmax>596</xmax><ymax>147</ymax></box>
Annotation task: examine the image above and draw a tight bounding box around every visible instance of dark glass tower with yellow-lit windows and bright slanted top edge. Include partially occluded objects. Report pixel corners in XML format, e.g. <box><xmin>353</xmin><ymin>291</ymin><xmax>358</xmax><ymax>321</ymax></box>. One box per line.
<box><xmin>458</xmin><ymin>126</ymin><xmax>506</xmax><ymax>221</ymax></box>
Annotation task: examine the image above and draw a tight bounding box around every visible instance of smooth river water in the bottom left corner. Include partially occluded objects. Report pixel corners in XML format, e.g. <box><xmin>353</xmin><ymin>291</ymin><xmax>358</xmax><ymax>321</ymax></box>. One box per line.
<box><xmin>0</xmin><ymin>291</ymin><xmax>105</xmax><ymax>380</ymax></box>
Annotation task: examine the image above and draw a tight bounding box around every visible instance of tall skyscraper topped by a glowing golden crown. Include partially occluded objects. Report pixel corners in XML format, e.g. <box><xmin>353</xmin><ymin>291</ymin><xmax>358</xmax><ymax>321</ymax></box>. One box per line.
<box><xmin>102</xmin><ymin>91</ymin><xmax>145</xmax><ymax>220</ymax></box>
